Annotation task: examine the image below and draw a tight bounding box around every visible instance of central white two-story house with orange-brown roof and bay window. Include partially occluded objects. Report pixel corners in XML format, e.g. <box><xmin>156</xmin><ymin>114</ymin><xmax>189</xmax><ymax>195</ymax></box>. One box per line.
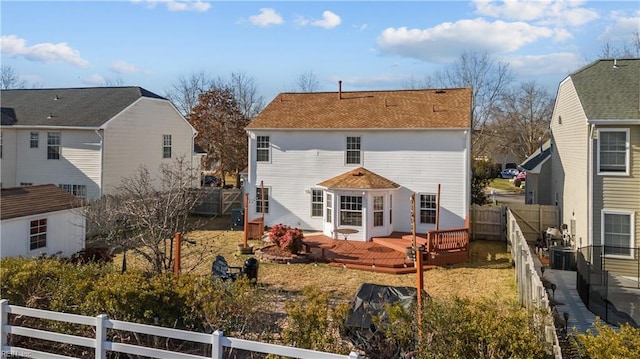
<box><xmin>244</xmin><ymin>88</ymin><xmax>471</xmax><ymax>241</ymax></box>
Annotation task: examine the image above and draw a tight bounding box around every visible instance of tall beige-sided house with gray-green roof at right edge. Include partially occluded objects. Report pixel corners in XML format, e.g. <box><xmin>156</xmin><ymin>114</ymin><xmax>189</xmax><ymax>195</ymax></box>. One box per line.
<box><xmin>550</xmin><ymin>59</ymin><xmax>640</xmax><ymax>277</ymax></box>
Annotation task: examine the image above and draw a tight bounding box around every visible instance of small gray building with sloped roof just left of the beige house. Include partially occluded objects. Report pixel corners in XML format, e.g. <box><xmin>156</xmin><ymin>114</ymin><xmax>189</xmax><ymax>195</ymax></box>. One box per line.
<box><xmin>520</xmin><ymin>141</ymin><xmax>555</xmax><ymax>205</ymax></box>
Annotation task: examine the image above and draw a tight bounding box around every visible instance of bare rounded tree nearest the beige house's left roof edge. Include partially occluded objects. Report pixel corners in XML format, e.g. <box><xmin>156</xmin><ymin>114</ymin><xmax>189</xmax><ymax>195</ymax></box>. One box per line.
<box><xmin>485</xmin><ymin>82</ymin><xmax>555</xmax><ymax>162</ymax></box>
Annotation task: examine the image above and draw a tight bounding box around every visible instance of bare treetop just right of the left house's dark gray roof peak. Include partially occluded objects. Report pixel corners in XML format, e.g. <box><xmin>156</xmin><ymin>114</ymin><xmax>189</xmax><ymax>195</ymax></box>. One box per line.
<box><xmin>165</xmin><ymin>71</ymin><xmax>214</xmax><ymax>117</ymax></box>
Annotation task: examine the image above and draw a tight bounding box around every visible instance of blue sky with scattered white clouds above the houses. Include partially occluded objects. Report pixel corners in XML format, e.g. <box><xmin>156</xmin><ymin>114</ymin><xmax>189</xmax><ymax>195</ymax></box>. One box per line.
<box><xmin>0</xmin><ymin>0</ymin><xmax>640</xmax><ymax>103</ymax></box>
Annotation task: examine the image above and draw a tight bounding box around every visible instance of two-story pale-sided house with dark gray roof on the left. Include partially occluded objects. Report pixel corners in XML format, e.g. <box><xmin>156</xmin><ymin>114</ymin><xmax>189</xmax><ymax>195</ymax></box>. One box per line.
<box><xmin>0</xmin><ymin>87</ymin><xmax>200</xmax><ymax>198</ymax></box>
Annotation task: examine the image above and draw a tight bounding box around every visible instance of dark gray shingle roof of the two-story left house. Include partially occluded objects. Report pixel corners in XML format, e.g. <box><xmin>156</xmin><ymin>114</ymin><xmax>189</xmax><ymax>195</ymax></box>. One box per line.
<box><xmin>0</xmin><ymin>87</ymin><xmax>166</xmax><ymax>127</ymax></box>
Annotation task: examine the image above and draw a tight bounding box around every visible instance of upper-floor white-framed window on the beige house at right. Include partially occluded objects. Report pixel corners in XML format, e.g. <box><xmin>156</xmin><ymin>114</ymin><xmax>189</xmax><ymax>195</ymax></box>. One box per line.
<box><xmin>598</xmin><ymin>128</ymin><xmax>629</xmax><ymax>174</ymax></box>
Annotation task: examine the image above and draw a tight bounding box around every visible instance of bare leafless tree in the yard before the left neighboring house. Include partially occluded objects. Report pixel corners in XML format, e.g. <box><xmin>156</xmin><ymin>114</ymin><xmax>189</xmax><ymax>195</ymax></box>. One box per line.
<box><xmin>82</xmin><ymin>157</ymin><xmax>204</xmax><ymax>273</ymax></box>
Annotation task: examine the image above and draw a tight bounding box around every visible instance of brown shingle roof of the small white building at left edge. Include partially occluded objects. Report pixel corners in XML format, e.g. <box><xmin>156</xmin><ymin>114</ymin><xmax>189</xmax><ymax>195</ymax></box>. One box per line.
<box><xmin>0</xmin><ymin>184</ymin><xmax>82</xmax><ymax>220</ymax></box>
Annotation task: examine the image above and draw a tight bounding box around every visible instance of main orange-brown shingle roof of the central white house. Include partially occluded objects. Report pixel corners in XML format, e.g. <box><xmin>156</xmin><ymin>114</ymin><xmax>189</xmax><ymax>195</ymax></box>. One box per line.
<box><xmin>247</xmin><ymin>88</ymin><xmax>471</xmax><ymax>129</ymax></box>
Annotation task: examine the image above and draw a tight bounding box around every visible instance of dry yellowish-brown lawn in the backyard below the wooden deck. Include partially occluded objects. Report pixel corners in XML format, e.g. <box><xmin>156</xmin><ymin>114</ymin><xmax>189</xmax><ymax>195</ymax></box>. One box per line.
<box><xmin>110</xmin><ymin>217</ymin><xmax>517</xmax><ymax>301</ymax></box>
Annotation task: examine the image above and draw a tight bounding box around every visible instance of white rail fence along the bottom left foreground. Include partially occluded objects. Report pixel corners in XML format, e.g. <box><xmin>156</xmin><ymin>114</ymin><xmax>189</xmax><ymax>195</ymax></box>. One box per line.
<box><xmin>0</xmin><ymin>299</ymin><xmax>361</xmax><ymax>359</ymax></box>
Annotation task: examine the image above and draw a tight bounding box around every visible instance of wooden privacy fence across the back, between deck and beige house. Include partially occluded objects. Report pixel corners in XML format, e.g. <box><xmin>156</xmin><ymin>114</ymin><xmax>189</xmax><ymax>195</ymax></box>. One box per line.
<box><xmin>469</xmin><ymin>203</ymin><xmax>560</xmax><ymax>243</ymax></box>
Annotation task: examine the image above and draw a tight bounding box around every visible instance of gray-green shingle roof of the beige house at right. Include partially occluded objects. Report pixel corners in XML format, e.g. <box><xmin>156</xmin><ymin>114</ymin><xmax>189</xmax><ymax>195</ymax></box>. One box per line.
<box><xmin>570</xmin><ymin>59</ymin><xmax>640</xmax><ymax>120</ymax></box>
